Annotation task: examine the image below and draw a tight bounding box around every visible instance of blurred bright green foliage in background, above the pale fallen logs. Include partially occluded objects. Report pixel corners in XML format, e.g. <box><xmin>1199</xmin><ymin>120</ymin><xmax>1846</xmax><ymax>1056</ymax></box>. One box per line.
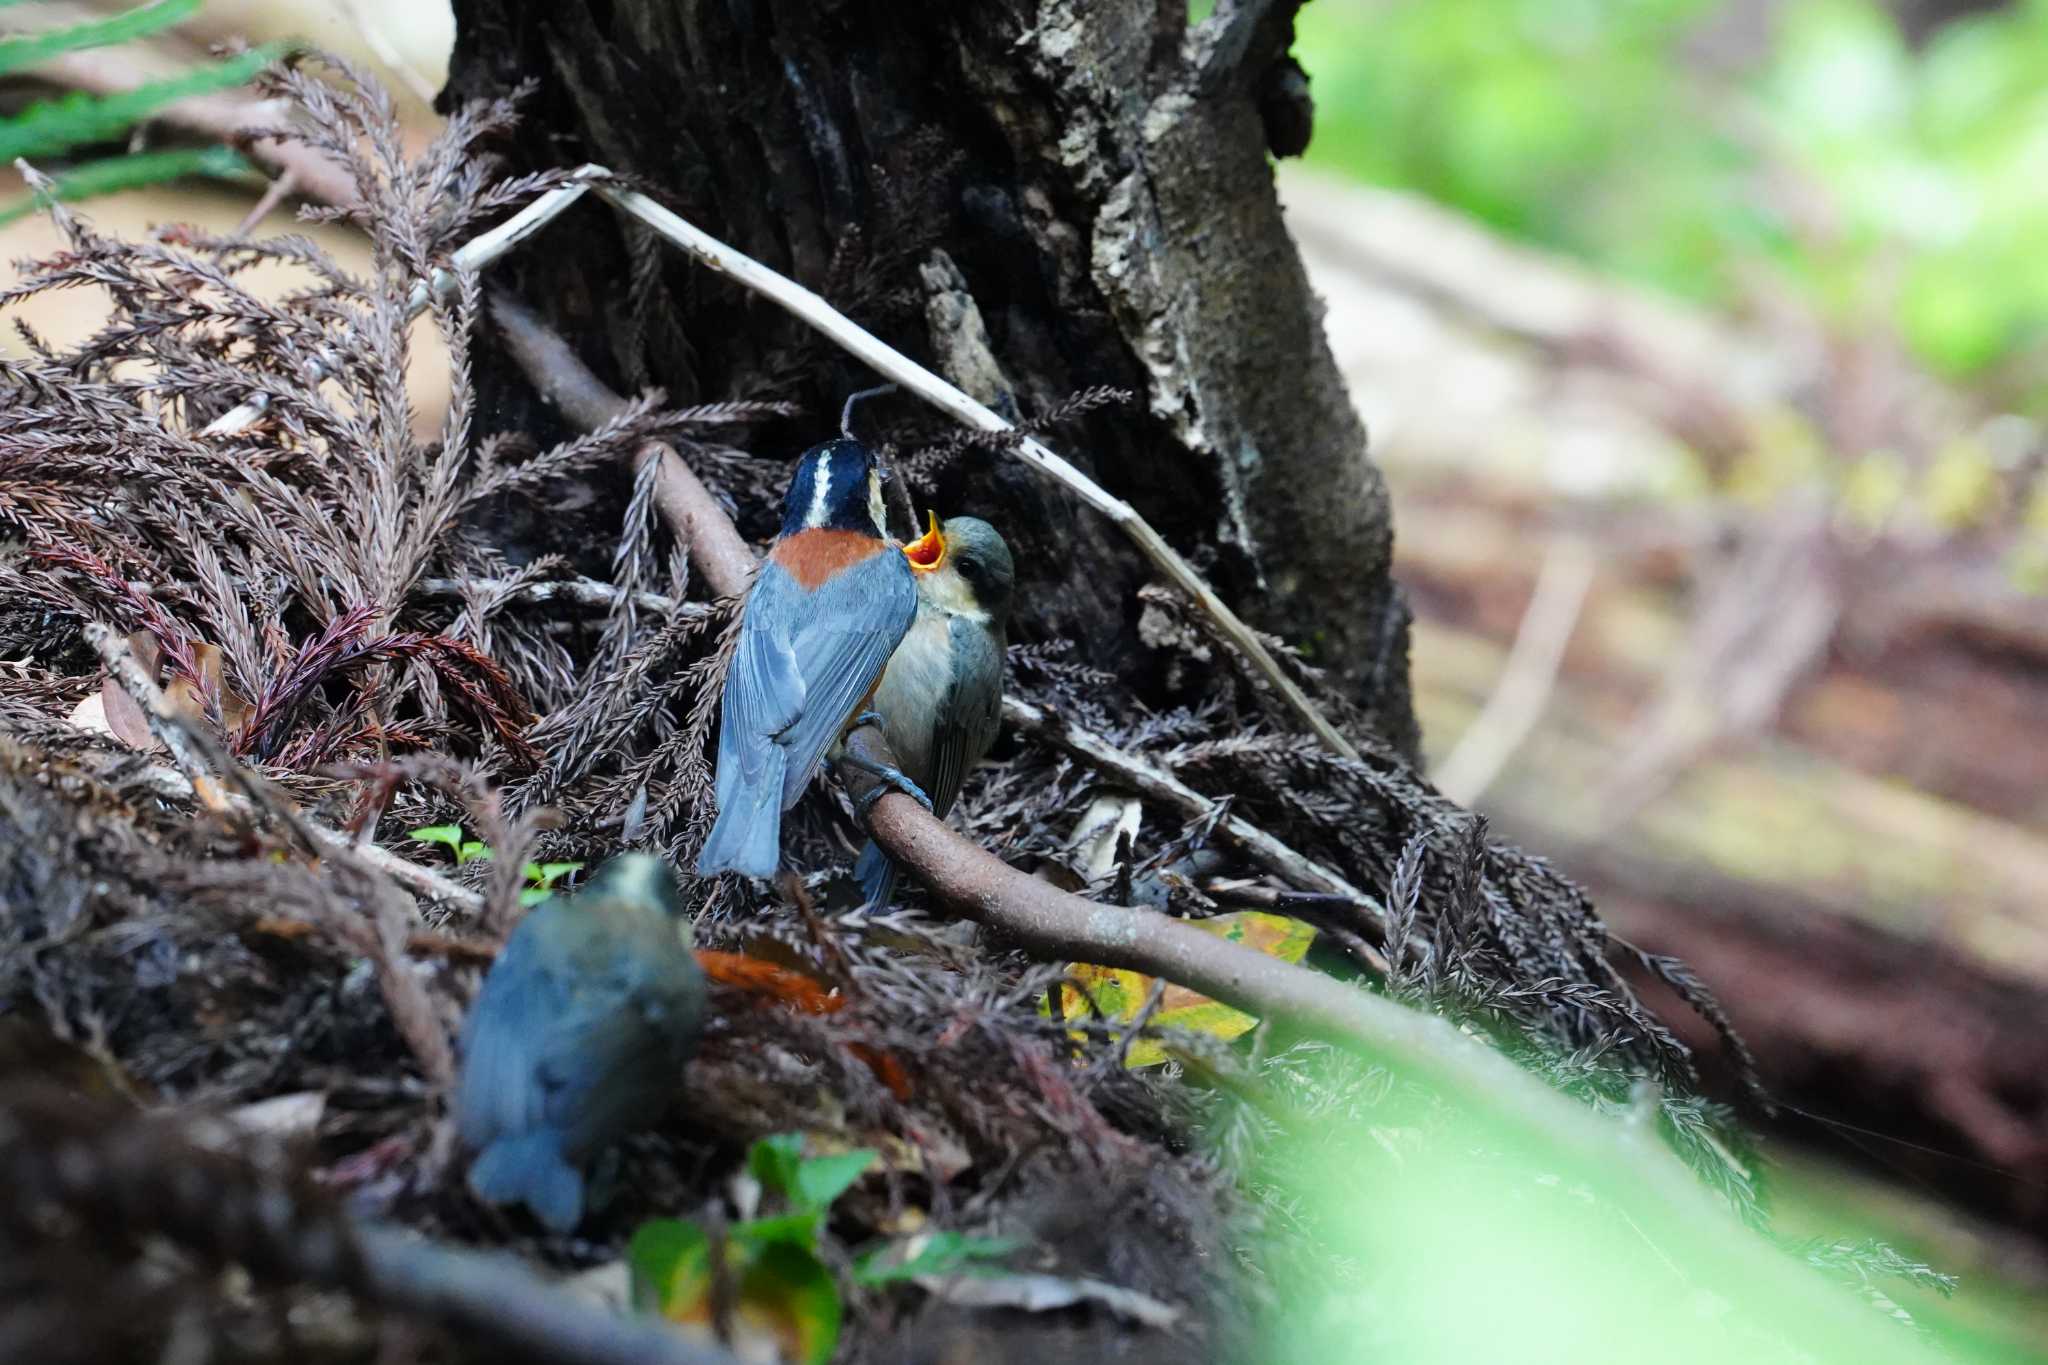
<box><xmin>1296</xmin><ymin>0</ymin><xmax>2048</xmax><ymax>397</ymax></box>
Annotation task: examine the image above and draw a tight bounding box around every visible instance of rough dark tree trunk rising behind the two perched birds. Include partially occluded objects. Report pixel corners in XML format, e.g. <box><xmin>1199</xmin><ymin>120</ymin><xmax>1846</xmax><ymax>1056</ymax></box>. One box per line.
<box><xmin>442</xmin><ymin>0</ymin><xmax>1415</xmax><ymax>755</ymax></box>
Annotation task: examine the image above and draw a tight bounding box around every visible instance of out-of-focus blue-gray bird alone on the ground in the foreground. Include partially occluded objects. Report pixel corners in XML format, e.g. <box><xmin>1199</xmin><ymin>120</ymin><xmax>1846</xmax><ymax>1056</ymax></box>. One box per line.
<box><xmin>455</xmin><ymin>853</ymin><xmax>705</xmax><ymax>1232</ymax></box>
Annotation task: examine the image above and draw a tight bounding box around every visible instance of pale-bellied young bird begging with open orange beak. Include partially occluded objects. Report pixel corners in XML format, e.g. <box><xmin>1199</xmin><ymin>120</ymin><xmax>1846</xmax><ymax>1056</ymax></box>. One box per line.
<box><xmin>854</xmin><ymin>516</ymin><xmax>1016</xmax><ymax>905</ymax></box>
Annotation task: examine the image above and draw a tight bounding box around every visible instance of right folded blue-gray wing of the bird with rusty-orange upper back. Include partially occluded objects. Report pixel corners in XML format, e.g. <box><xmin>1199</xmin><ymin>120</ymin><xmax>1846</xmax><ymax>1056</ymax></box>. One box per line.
<box><xmin>764</xmin><ymin>551</ymin><xmax>918</xmax><ymax>810</ymax></box>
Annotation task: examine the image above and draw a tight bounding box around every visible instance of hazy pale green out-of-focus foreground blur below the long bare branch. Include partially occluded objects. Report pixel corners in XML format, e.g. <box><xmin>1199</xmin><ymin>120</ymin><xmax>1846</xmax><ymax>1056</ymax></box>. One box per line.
<box><xmin>1247</xmin><ymin>1055</ymin><xmax>2036</xmax><ymax>1365</ymax></box>
